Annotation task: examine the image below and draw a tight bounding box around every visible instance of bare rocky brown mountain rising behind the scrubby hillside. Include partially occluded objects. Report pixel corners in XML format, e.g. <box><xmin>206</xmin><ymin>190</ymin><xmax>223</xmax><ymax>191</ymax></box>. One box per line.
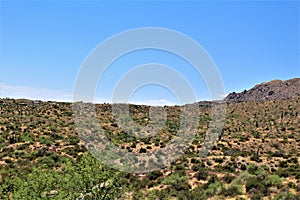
<box><xmin>225</xmin><ymin>78</ymin><xmax>300</xmax><ymax>103</ymax></box>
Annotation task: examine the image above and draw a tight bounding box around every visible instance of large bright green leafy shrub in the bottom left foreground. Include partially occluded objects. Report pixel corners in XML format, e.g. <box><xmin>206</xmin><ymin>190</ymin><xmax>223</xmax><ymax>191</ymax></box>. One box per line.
<box><xmin>0</xmin><ymin>153</ymin><xmax>126</xmax><ymax>199</ymax></box>
